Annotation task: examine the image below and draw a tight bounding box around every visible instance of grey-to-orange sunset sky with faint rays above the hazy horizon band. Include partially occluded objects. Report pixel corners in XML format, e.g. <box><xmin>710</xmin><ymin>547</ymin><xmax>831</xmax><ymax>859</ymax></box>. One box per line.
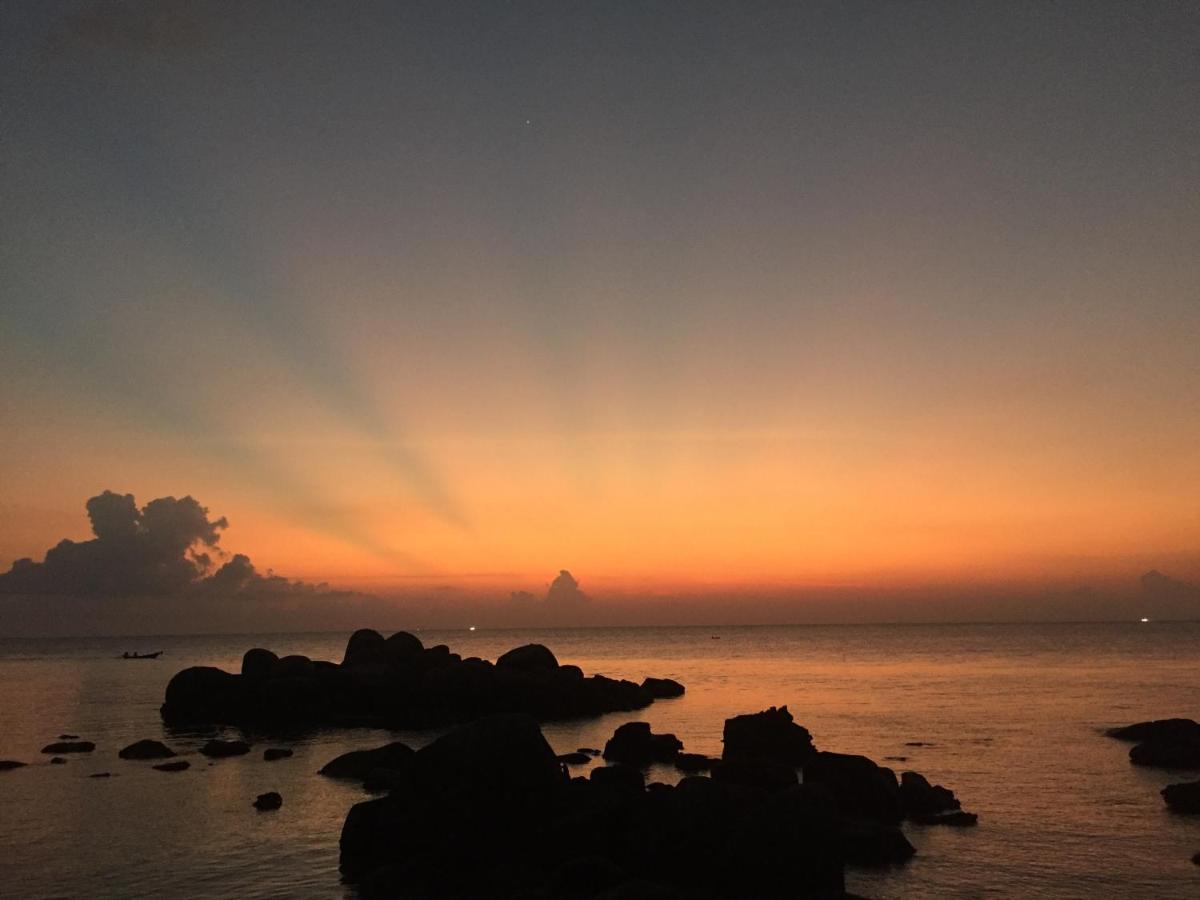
<box><xmin>0</xmin><ymin>0</ymin><xmax>1200</xmax><ymax>587</ymax></box>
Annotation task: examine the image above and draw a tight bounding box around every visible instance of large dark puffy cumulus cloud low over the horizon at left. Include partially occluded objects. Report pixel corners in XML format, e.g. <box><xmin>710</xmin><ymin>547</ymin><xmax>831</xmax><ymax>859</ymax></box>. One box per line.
<box><xmin>0</xmin><ymin>491</ymin><xmax>325</xmax><ymax>596</ymax></box>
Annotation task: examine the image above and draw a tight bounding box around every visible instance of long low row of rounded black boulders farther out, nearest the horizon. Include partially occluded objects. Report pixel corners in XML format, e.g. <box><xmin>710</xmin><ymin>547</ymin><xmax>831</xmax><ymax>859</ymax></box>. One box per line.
<box><xmin>162</xmin><ymin>629</ymin><xmax>684</xmax><ymax>730</ymax></box>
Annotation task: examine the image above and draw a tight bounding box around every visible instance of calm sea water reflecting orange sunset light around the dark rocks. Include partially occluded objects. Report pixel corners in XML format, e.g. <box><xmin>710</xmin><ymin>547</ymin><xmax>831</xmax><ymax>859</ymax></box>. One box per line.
<box><xmin>0</xmin><ymin>623</ymin><xmax>1200</xmax><ymax>900</ymax></box>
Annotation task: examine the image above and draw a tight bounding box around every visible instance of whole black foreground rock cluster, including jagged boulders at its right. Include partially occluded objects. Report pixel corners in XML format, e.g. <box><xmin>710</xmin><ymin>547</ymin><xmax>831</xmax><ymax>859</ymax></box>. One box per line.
<box><xmin>336</xmin><ymin>707</ymin><xmax>976</xmax><ymax>900</ymax></box>
